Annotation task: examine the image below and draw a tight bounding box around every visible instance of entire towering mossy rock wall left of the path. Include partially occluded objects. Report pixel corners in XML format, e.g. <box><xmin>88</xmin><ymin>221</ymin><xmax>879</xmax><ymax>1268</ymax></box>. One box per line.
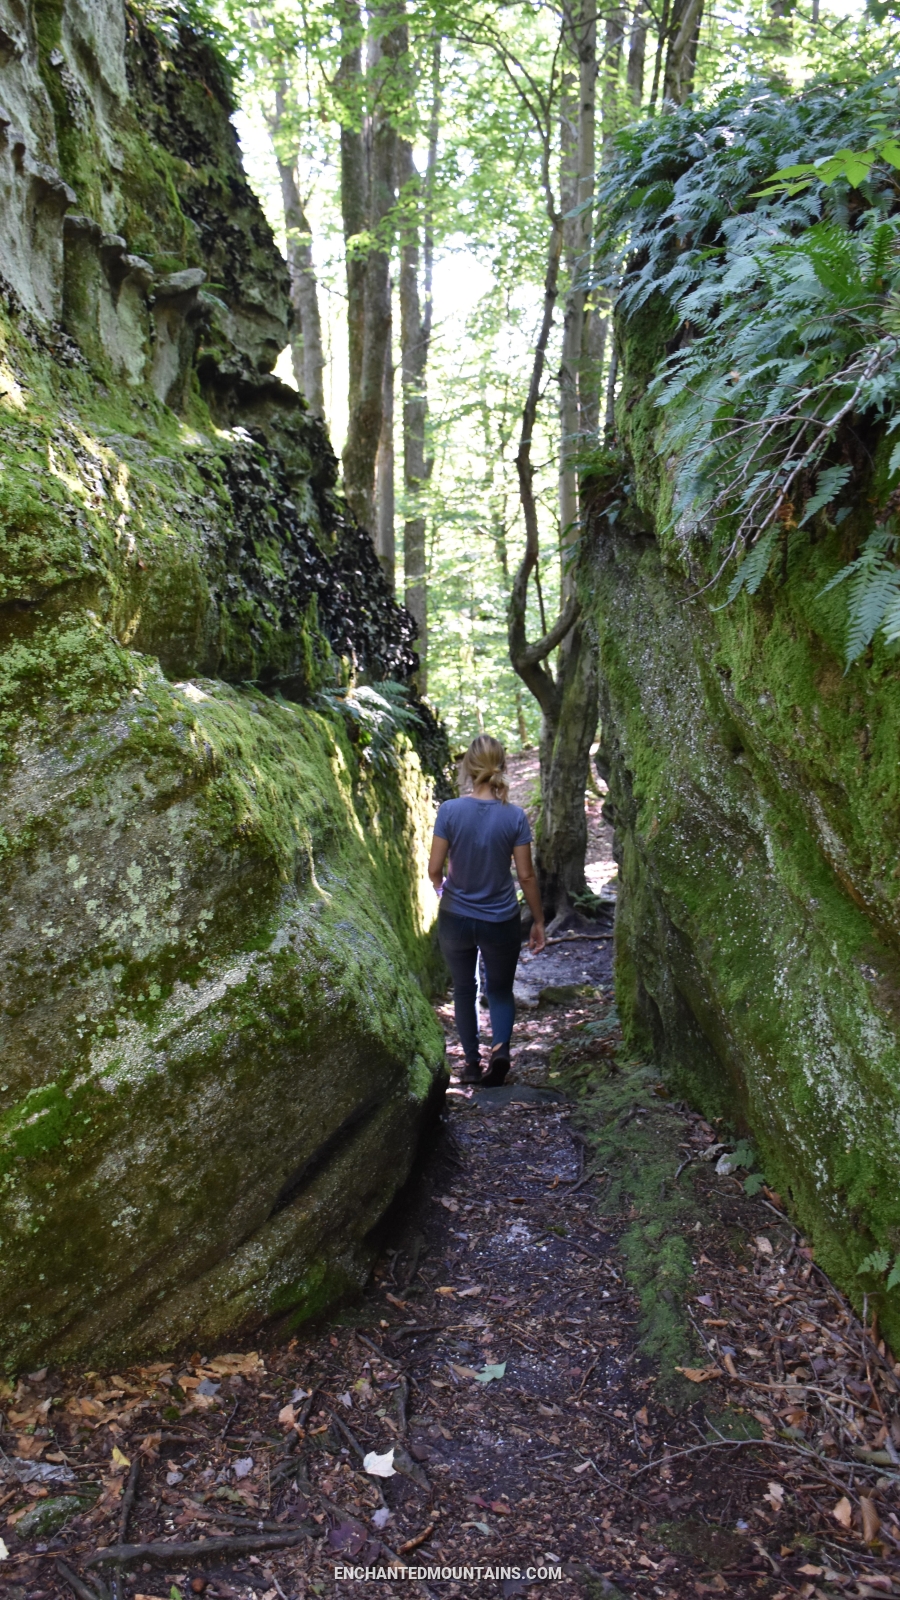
<box><xmin>0</xmin><ymin>0</ymin><xmax>444</xmax><ymax>1366</ymax></box>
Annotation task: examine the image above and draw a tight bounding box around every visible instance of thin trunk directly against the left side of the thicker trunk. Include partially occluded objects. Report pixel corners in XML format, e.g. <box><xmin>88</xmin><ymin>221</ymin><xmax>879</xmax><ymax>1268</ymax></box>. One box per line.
<box><xmin>336</xmin><ymin>0</ymin><xmax>368</xmax><ymax>416</ymax></box>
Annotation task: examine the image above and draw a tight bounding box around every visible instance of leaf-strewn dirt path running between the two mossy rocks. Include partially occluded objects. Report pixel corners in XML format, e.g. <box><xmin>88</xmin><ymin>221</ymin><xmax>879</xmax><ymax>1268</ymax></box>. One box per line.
<box><xmin>0</xmin><ymin>930</ymin><xmax>900</xmax><ymax>1600</ymax></box>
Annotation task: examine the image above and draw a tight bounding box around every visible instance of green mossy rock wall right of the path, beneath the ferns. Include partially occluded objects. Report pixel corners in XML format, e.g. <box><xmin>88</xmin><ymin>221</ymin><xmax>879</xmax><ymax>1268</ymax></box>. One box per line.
<box><xmin>585</xmin><ymin>310</ymin><xmax>900</xmax><ymax>1342</ymax></box>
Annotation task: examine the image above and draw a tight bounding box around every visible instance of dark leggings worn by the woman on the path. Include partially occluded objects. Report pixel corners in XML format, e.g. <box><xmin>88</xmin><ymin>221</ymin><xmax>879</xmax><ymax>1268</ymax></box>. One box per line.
<box><xmin>437</xmin><ymin>910</ymin><xmax>522</xmax><ymax>1061</ymax></box>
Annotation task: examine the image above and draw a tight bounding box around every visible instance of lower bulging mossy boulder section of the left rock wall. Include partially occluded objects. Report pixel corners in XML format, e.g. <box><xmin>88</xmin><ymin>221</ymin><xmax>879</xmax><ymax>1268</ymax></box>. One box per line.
<box><xmin>0</xmin><ymin>669</ymin><xmax>444</xmax><ymax>1366</ymax></box>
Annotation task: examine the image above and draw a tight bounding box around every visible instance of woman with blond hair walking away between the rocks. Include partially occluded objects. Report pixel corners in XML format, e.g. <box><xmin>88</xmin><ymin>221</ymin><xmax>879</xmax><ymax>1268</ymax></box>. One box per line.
<box><xmin>428</xmin><ymin>733</ymin><xmax>544</xmax><ymax>1086</ymax></box>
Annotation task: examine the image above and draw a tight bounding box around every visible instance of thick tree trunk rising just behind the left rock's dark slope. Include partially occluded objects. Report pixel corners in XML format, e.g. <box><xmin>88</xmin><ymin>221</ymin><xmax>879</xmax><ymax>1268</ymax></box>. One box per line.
<box><xmin>343</xmin><ymin>8</ymin><xmax>400</xmax><ymax>533</ymax></box>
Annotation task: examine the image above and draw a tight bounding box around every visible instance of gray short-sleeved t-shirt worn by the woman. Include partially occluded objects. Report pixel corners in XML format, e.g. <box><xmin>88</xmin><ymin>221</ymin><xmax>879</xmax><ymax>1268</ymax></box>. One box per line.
<box><xmin>434</xmin><ymin>795</ymin><xmax>532</xmax><ymax>922</ymax></box>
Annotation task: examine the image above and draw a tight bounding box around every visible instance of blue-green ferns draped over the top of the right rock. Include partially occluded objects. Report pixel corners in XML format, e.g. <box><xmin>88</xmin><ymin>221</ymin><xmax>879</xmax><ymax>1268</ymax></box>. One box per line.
<box><xmin>599</xmin><ymin>69</ymin><xmax>900</xmax><ymax>664</ymax></box>
